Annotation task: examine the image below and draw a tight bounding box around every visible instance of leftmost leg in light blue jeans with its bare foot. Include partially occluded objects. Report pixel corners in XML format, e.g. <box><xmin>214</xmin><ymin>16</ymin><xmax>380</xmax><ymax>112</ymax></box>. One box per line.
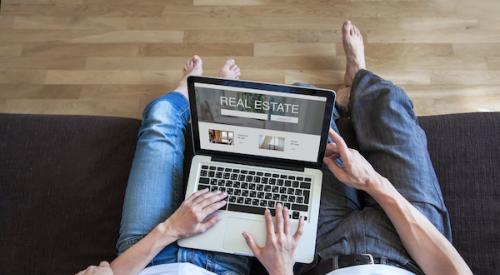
<box><xmin>117</xmin><ymin>57</ymin><xmax>202</xmax><ymax>260</ymax></box>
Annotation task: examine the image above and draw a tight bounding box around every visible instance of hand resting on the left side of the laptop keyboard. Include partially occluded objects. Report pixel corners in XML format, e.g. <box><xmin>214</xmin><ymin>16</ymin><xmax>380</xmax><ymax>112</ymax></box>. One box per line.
<box><xmin>165</xmin><ymin>189</ymin><xmax>227</xmax><ymax>239</ymax></box>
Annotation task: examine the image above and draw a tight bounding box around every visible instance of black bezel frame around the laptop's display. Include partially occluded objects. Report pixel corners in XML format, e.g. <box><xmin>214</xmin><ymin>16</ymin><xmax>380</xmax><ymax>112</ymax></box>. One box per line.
<box><xmin>188</xmin><ymin>76</ymin><xmax>335</xmax><ymax>168</ymax></box>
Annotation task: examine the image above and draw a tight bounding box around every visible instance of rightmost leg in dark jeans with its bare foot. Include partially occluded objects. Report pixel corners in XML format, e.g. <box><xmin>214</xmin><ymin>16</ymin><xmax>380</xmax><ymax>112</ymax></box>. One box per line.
<box><xmin>343</xmin><ymin>22</ymin><xmax>451</xmax><ymax>238</ymax></box>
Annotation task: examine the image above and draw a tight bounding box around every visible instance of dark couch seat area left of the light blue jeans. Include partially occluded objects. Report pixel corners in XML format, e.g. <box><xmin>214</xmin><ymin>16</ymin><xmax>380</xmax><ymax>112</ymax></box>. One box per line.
<box><xmin>0</xmin><ymin>114</ymin><xmax>140</xmax><ymax>274</ymax></box>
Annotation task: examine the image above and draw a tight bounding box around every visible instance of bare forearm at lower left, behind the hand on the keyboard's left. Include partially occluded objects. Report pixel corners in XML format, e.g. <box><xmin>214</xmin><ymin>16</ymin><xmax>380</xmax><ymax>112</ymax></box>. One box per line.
<box><xmin>111</xmin><ymin>222</ymin><xmax>177</xmax><ymax>275</ymax></box>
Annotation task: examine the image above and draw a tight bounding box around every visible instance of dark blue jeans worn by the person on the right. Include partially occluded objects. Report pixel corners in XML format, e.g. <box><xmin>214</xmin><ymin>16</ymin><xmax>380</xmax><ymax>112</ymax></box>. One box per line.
<box><xmin>297</xmin><ymin>70</ymin><xmax>451</xmax><ymax>271</ymax></box>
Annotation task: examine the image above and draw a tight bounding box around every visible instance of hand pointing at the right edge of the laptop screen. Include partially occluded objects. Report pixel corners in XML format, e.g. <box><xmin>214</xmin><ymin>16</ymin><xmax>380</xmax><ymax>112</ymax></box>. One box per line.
<box><xmin>323</xmin><ymin>129</ymin><xmax>382</xmax><ymax>191</ymax></box>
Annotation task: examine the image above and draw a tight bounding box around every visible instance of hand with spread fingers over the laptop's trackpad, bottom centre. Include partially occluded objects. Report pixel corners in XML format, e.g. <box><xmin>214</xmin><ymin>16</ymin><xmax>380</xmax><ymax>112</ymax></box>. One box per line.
<box><xmin>243</xmin><ymin>204</ymin><xmax>304</xmax><ymax>275</ymax></box>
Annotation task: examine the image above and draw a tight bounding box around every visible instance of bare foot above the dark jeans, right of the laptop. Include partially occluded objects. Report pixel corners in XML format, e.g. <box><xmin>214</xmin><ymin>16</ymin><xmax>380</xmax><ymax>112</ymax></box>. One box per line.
<box><xmin>342</xmin><ymin>21</ymin><xmax>366</xmax><ymax>87</ymax></box>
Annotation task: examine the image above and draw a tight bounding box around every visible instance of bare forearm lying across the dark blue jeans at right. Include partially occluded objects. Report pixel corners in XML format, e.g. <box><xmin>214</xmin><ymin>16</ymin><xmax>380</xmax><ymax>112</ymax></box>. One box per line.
<box><xmin>366</xmin><ymin>177</ymin><xmax>472</xmax><ymax>274</ymax></box>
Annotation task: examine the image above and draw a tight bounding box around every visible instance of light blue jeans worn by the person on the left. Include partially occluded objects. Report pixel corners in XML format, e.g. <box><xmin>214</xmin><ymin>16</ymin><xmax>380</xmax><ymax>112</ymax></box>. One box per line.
<box><xmin>117</xmin><ymin>92</ymin><xmax>252</xmax><ymax>274</ymax></box>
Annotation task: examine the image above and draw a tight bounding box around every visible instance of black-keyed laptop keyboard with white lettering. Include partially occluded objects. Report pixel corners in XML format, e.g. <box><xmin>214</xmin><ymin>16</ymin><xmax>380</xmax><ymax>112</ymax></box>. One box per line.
<box><xmin>198</xmin><ymin>164</ymin><xmax>312</xmax><ymax>220</ymax></box>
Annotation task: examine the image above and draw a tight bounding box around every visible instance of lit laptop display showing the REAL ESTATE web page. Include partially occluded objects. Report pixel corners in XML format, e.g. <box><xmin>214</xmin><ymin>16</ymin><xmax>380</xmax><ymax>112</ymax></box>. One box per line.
<box><xmin>194</xmin><ymin>83</ymin><xmax>327</xmax><ymax>162</ymax></box>
